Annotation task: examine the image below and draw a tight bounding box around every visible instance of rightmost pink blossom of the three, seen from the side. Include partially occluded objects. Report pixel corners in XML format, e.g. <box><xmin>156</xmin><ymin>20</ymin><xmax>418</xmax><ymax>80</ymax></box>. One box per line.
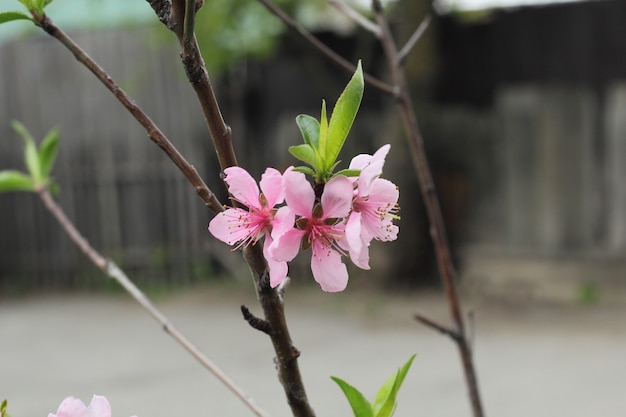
<box><xmin>342</xmin><ymin>145</ymin><xmax>399</xmax><ymax>269</ymax></box>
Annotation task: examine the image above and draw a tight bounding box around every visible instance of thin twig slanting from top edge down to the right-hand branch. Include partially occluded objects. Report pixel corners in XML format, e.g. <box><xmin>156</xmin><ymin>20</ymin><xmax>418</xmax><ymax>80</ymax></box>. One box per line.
<box><xmin>252</xmin><ymin>0</ymin><xmax>394</xmax><ymax>96</ymax></box>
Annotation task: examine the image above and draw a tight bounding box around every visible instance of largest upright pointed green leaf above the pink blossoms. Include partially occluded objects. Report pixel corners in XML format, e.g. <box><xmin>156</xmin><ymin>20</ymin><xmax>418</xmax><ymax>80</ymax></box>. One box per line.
<box><xmin>320</xmin><ymin>61</ymin><xmax>365</xmax><ymax>167</ymax></box>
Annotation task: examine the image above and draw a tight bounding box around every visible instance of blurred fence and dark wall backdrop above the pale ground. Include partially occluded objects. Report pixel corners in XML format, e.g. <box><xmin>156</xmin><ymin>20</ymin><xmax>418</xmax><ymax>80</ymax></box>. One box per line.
<box><xmin>0</xmin><ymin>0</ymin><xmax>626</xmax><ymax>301</ymax></box>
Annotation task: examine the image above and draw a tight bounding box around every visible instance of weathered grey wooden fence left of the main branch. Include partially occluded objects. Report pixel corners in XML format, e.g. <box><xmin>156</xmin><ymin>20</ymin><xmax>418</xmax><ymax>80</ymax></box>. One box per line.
<box><xmin>0</xmin><ymin>31</ymin><xmax>233</xmax><ymax>290</ymax></box>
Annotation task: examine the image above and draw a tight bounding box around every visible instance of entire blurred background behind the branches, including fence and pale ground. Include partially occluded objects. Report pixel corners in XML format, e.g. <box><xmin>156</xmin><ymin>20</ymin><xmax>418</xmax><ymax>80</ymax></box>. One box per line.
<box><xmin>0</xmin><ymin>0</ymin><xmax>626</xmax><ymax>417</ymax></box>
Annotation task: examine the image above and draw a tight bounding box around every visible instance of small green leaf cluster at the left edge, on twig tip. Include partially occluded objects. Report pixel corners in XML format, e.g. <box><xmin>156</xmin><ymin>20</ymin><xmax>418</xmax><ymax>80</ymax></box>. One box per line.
<box><xmin>0</xmin><ymin>121</ymin><xmax>59</xmax><ymax>192</ymax></box>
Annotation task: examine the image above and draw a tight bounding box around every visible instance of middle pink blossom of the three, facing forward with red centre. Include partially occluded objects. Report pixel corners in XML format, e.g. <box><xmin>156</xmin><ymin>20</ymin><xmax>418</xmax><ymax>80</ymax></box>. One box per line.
<box><xmin>269</xmin><ymin>168</ymin><xmax>354</xmax><ymax>292</ymax></box>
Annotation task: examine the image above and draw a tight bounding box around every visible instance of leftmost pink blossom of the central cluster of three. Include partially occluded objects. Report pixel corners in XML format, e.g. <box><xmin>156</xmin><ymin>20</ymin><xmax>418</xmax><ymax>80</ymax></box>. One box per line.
<box><xmin>209</xmin><ymin>167</ymin><xmax>294</xmax><ymax>287</ymax></box>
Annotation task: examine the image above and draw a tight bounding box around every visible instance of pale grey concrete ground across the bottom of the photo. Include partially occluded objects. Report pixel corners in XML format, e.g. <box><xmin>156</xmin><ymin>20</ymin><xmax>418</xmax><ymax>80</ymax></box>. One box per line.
<box><xmin>0</xmin><ymin>282</ymin><xmax>626</xmax><ymax>417</ymax></box>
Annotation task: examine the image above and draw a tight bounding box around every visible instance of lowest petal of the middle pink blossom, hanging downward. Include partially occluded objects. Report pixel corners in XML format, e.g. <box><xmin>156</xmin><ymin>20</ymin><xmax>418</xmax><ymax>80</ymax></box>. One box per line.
<box><xmin>311</xmin><ymin>242</ymin><xmax>348</xmax><ymax>292</ymax></box>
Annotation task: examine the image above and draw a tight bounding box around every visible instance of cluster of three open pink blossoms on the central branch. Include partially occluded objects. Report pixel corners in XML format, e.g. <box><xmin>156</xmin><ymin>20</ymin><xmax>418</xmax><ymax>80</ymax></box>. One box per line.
<box><xmin>209</xmin><ymin>145</ymin><xmax>399</xmax><ymax>292</ymax></box>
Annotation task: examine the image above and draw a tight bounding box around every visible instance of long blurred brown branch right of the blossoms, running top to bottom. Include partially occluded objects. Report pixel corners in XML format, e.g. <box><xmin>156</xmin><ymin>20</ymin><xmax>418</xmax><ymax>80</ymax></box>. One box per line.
<box><xmin>372</xmin><ymin>0</ymin><xmax>483</xmax><ymax>417</ymax></box>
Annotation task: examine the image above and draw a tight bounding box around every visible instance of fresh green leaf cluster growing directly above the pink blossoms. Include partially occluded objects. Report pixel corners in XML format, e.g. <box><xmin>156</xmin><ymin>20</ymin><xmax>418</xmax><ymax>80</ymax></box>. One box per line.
<box><xmin>289</xmin><ymin>61</ymin><xmax>364</xmax><ymax>184</ymax></box>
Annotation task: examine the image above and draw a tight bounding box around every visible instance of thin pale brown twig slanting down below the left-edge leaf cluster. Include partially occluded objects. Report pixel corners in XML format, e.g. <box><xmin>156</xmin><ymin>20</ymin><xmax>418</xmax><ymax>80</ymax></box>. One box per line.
<box><xmin>38</xmin><ymin>188</ymin><xmax>268</xmax><ymax>417</ymax></box>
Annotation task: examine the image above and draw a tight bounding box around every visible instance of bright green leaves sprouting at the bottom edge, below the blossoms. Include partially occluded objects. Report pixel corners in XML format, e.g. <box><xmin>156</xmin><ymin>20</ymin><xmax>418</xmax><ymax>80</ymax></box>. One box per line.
<box><xmin>331</xmin><ymin>355</ymin><xmax>415</xmax><ymax>417</ymax></box>
